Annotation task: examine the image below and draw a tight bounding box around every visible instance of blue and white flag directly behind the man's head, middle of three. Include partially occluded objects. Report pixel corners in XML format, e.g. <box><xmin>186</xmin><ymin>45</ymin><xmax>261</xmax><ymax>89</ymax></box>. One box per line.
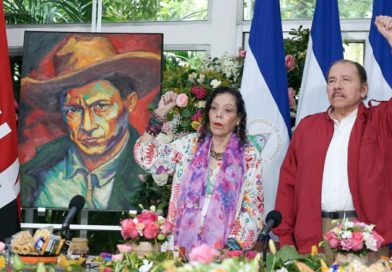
<box><xmin>295</xmin><ymin>0</ymin><xmax>343</xmax><ymax>125</ymax></box>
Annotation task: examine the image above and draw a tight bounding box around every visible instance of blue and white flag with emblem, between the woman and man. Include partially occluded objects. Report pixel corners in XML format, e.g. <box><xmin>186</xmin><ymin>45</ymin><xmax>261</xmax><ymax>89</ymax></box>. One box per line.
<box><xmin>241</xmin><ymin>0</ymin><xmax>290</xmax><ymax>217</ymax></box>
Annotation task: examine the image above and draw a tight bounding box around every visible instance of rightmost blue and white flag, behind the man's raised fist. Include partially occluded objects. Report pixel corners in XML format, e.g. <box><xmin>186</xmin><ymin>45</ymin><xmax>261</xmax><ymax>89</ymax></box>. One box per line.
<box><xmin>364</xmin><ymin>0</ymin><xmax>392</xmax><ymax>101</ymax></box>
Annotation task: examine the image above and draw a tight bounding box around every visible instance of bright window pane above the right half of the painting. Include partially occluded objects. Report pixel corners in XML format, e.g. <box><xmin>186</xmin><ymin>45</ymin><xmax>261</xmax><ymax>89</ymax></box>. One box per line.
<box><xmin>102</xmin><ymin>0</ymin><xmax>208</xmax><ymax>23</ymax></box>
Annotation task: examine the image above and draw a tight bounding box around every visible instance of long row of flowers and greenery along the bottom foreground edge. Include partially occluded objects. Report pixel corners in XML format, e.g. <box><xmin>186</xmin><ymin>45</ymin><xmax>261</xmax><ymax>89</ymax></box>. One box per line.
<box><xmin>95</xmin><ymin>240</ymin><xmax>392</xmax><ymax>272</ymax></box>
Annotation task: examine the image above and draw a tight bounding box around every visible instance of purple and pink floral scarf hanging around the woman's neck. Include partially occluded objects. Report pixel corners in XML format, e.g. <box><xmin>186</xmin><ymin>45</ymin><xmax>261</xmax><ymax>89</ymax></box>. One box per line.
<box><xmin>174</xmin><ymin>133</ymin><xmax>245</xmax><ymax>253</ymax></box>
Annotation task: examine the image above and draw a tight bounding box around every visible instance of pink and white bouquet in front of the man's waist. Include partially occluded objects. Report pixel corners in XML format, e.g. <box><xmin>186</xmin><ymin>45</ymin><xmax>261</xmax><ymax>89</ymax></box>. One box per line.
<box><xmin>324</xmin><ymin>218</ymin><xmax>384</xmax><ymax>254</ymax></box>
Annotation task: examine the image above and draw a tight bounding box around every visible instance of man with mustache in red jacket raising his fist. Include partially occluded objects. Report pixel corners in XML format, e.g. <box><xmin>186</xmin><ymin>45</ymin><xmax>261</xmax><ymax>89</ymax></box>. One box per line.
<box><xmin>274</xmin><ymin>16</ymin><xmax>392</xmax><ymax>254</ymax></box>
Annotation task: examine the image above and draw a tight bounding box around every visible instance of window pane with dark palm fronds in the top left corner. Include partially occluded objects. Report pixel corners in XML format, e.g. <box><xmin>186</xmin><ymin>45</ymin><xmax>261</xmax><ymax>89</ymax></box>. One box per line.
<box><xmin>3</xmin><ymin>0</ymin><xmax>92</xmax><ymax>24</ymax></box>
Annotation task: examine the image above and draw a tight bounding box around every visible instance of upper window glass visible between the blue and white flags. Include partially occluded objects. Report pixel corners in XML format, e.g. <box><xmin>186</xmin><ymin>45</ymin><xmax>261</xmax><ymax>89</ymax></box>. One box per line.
<box><xmin>244</xmin><ymin>0</ymin><xmax>373</xmax><ymax>20</ymax></box>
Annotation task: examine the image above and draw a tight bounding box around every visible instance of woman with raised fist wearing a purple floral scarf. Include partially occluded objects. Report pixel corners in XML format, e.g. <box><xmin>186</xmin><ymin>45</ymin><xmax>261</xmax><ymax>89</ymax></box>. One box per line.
<box><xmin>134</xmin><ymin>87</ymin><xmax>264</xmax><ymax>253</ymax></box>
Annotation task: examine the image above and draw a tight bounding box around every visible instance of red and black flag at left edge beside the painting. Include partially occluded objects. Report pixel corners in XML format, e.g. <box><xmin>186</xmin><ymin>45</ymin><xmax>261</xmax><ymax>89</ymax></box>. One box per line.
<box><xmin>0</xmin><ymin>1</ymin><xmax>20</xmax><ymax>241</ymax></box>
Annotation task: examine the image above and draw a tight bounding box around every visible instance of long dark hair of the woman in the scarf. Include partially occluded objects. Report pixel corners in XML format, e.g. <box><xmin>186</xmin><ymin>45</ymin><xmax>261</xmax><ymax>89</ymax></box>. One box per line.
<box><xmin>198</xmin><ymin>87</ymin><xmax>248</xmax><ymax>146</ymax></box>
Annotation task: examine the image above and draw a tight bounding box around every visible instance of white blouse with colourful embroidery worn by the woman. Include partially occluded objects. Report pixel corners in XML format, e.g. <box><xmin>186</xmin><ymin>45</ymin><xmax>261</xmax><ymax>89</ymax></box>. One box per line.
<box><xmin>134</xmin><ymin>133</ymin><xmax>264</xmax><ymax>249</ymax></box>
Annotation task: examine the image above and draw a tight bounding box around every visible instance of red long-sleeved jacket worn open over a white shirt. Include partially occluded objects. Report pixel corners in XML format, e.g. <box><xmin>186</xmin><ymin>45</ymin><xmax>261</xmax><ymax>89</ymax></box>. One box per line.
<box><xmin>273</xmin><ymin>99</ymin><xmax>392</xmax><ymax>254</ymax></box>
